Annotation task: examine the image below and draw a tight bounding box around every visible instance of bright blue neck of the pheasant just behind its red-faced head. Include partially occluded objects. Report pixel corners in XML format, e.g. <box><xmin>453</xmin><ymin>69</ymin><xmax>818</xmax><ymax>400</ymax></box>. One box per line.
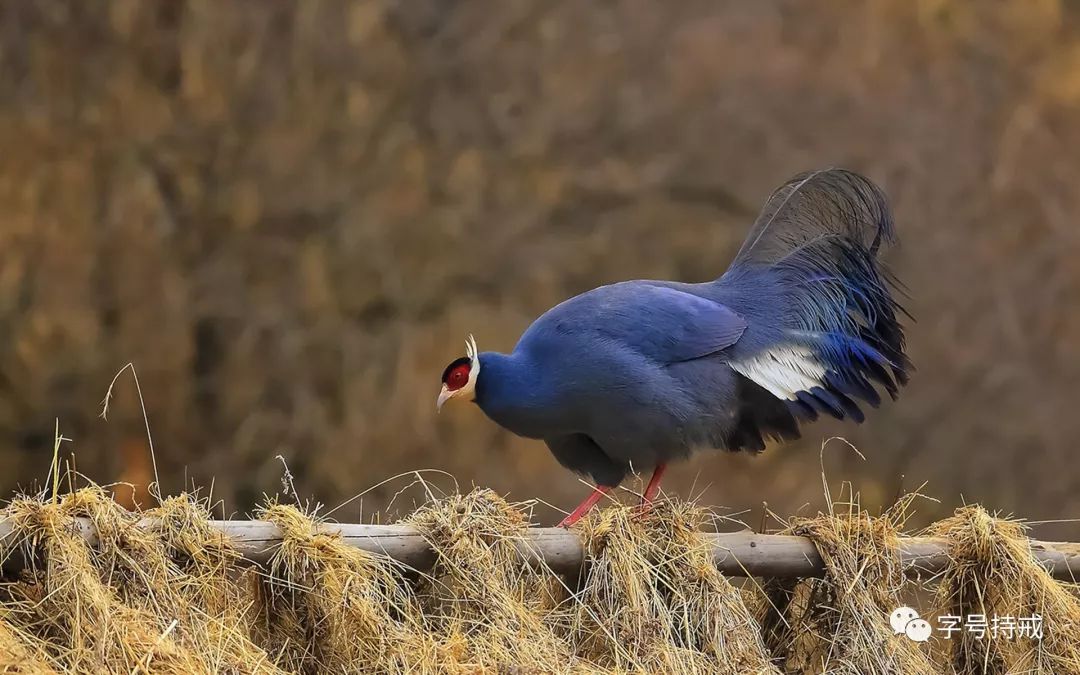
<box><xmin>476</xmin><ymin>352</ymin><xmax>554</xmax><ymax>438</ymax></box>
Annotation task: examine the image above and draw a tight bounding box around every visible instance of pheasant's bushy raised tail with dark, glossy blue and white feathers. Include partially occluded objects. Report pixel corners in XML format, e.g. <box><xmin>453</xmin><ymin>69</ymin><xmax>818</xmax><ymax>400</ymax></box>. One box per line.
<box><xmin>721</xmin><ymin>168</ymin><xmax>912</xmax><ymax>422</ymax></box>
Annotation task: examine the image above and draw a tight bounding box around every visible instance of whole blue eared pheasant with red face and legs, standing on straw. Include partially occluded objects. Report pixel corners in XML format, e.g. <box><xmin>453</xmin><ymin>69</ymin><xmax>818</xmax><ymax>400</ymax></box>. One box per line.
<box><xmin>437</xmin><ymin>168</ymin><xmax>910</xmax><ymax>526</ymax></box>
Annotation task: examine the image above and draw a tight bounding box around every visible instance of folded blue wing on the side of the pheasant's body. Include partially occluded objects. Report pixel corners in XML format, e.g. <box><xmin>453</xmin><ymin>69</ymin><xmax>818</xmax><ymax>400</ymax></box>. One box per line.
<box><xmin>594</xmin><ymin>283</ymin><xmax>746</xmax><ymax>363</ymax></box>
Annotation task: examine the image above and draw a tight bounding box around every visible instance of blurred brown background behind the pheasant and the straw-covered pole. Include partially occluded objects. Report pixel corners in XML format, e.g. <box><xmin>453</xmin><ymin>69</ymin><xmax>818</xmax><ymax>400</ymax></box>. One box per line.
<box><xmin>0</xmin><ymin>0</ymin><xmax>1080</xmax><ymax>538</ymax></box>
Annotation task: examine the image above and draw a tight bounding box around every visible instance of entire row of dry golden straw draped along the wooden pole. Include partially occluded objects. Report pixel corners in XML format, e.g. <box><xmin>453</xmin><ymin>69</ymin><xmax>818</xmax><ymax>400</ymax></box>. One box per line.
<box><xmin>0</xmin><ymin>487</ymin><xmax>1080</xmax><ymax>675</ymax></box>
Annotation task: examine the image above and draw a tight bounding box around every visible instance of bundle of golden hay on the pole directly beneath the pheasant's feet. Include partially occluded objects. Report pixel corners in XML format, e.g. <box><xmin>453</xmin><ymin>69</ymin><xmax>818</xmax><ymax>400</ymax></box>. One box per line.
<box><xmin>575</xmin><ymin>502</ymin><xmax>780</xmax><ymax>675</ymax></box>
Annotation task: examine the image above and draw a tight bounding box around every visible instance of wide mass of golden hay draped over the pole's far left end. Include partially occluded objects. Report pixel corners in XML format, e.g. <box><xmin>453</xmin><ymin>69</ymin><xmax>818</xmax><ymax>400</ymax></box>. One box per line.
<box><xmin>2</xmin><ymin>487</ymin><xmax>279</xmax><ymax>673</ymax></box>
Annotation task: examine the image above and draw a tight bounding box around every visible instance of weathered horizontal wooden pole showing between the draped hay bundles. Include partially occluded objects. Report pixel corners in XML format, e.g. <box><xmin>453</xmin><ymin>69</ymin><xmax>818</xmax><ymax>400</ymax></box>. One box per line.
<box><xmin>0</xmin><ymin>519</ymin><xmax>1080</xmax><ymax>581</ymax></box>
